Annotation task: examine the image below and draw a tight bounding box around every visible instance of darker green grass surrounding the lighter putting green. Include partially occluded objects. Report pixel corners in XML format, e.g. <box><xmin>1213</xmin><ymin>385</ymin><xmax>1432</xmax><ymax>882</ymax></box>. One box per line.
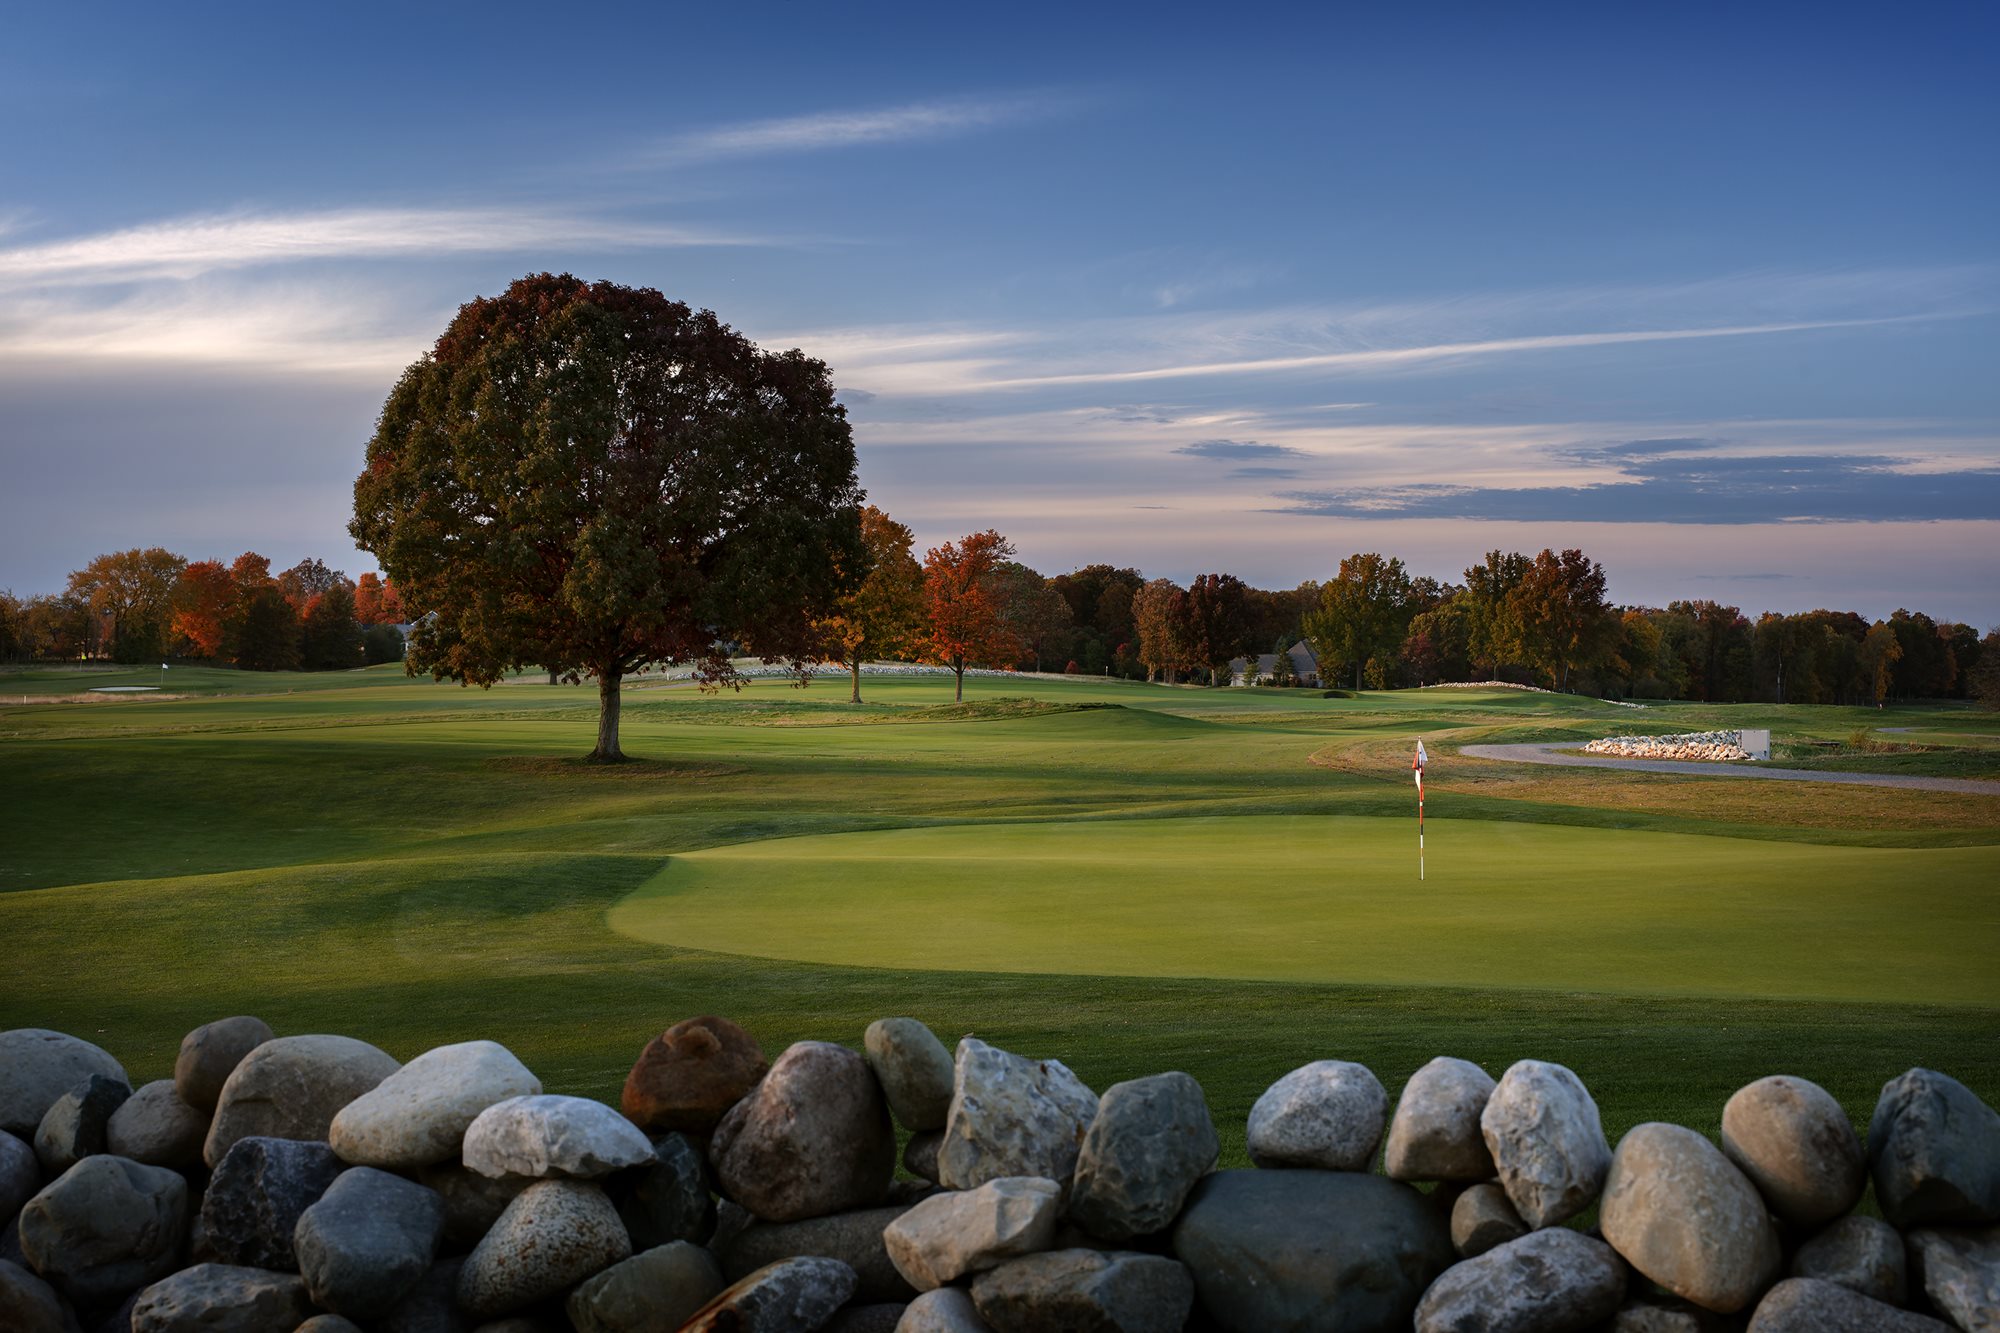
<box><xmin>0</xmin><ymin>669</ymin><xmax>2000</xmax><ymax>1161</ymax></box>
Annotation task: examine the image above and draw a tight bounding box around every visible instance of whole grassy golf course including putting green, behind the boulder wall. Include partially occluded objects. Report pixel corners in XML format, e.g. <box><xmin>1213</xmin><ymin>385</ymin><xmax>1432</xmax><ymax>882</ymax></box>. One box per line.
<box><xmin>0</xmin><ymin>669</ymin><xmax>2000</xmax><ymax>1161</ymax></box>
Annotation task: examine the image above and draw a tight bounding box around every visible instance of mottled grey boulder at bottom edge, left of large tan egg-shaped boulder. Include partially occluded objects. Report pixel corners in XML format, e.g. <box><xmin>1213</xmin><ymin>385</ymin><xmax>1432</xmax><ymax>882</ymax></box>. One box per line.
<box><xmin>1416</xmin><ymin>1227</ymin><xmax>1626</xmax><ymax>1333</ymax></box>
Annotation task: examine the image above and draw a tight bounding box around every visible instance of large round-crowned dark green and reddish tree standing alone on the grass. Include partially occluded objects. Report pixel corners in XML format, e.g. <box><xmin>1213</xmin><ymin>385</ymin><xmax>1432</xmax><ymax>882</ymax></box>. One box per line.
<box><xmin>350</xmin><ymin>274</ymin><xmax>862</xmax><ymax>763</ymax></box>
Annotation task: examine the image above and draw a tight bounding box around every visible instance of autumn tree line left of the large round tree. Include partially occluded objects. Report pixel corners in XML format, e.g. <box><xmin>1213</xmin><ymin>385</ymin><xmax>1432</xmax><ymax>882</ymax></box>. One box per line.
<box><xmin>0</xmin><ymin>546</ymin><xmax>404</xmax><ymax>671</ymax></box>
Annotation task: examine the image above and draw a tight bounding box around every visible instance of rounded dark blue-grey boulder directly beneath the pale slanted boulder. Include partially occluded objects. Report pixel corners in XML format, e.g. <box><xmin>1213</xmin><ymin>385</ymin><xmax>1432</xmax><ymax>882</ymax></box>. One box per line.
<box><xmin>292</xmin><ymin>1167</ymin><xmax>444</xmax><ymax>1319</ymax></box>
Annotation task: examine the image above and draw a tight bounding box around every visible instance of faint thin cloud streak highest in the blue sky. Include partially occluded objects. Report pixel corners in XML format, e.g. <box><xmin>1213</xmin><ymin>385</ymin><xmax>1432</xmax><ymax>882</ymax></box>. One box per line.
<box><xmin>636</xmin><ymin>92</ymin><xmax>1076</xmax><ymax>164</ymax></box>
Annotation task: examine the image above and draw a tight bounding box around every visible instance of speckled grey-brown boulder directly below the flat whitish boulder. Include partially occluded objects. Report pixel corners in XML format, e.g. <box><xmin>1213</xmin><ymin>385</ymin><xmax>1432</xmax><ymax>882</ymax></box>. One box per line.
<box><xmin>458</xmin><ymin>1181</ymin><xmax>632</xmax><ymax>1319</ymax></box>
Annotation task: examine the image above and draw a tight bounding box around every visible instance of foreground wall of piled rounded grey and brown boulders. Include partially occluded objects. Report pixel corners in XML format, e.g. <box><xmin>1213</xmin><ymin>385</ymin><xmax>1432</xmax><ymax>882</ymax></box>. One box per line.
<box><xmin>0</xmin><ymin>1017</ymin><xmax>2000</xmax><ymax>1333</ymax></box>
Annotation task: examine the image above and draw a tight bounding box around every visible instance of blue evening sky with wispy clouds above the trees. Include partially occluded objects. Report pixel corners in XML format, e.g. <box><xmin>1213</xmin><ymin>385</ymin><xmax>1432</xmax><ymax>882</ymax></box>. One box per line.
<box><xmin>0</xmin><ymin>4</ymin><xmax>2000</xmax><ymax>628</ymax></box>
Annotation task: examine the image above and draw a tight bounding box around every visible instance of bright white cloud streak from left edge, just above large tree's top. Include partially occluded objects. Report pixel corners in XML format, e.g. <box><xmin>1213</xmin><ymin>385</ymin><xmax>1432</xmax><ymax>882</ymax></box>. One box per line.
<box><xmin>0</xmin><ymin>208</ymin><xmax>780</xmax><ymax>286</ymax></box>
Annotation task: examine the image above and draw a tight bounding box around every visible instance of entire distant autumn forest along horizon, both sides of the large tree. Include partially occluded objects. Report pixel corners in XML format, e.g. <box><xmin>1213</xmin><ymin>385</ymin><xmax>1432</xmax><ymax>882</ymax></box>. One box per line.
<box><xmin>0</xmin><ymin>536</ymin><xmax>2000</xmax><ymax>707</ymax></box>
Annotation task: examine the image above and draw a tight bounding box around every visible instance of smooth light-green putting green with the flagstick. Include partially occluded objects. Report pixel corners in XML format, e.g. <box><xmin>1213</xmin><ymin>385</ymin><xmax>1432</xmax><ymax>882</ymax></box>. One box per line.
<box><xmin>610</xmin><ymin>817</ymin><xmax>2000</xmax><ymax>1007</ymax></box>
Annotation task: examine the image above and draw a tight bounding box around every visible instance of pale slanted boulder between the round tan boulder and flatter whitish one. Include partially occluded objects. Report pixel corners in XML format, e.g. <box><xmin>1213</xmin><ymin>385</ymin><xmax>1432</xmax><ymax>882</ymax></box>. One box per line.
<box><xmin>326</xmin><ymin>1041</ymin><xmax>544</xmax><ymax>1175</ymax></box>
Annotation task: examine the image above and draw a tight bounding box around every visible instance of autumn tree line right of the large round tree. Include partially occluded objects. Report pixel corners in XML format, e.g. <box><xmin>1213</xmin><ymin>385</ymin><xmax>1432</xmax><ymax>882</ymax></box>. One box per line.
<box><xmin>804</xmin><ymin>506</ymin><xmax>2000</xmax><ymax>705</ymax></box>
